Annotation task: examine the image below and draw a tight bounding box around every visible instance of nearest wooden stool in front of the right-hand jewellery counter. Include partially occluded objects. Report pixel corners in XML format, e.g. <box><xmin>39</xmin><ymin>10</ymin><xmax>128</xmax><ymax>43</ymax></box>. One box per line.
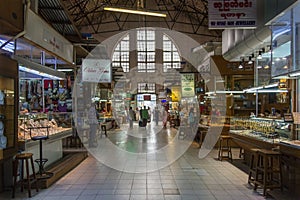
<box><xmin>254</xmin><ymin>149</ymin><xmax>282</xmax><ymax>196</ymax></box>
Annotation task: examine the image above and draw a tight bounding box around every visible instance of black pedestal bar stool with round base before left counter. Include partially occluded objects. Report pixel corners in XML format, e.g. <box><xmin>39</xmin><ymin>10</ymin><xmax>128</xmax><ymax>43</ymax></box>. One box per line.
<box><xmin>29</xmin><ymin>126</ymin><xmax>53</xmax><ymax>179</ymax></box>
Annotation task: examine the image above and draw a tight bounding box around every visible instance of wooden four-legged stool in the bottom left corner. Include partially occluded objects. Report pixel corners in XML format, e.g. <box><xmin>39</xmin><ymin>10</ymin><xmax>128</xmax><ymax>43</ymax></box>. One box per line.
<box><xmin>12</xmin><ymin>153</ymin><xmax>39</xmax><ymax>198</ymax></box>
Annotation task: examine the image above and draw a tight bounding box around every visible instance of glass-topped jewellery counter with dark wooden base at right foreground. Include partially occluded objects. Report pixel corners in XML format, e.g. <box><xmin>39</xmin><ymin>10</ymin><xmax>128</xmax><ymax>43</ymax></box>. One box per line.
<box><xmin>229</xmin><ymin>118</ymin><xmax>300</xmax><ymax>196</ymax></box>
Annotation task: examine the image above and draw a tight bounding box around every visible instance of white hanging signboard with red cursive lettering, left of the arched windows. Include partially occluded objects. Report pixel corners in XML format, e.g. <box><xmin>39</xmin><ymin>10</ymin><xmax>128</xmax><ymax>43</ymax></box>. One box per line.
<box><xmin>82</xmin><ymin>59</ymin><xmax>111</xmax><ymax>83</ymax></box>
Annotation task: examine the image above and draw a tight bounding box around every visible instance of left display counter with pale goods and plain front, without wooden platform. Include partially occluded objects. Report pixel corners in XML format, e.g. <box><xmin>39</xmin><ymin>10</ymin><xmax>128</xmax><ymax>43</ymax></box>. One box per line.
<box><xmin>18</xmin><ymin>113</ymin><xmax>72</xmax><ymax>167</ymax></box>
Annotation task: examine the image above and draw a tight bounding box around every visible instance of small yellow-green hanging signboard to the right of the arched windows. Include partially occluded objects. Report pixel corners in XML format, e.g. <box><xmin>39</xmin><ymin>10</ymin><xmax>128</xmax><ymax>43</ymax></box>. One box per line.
<box><xmin>181</xmin><ymin>73</ymin><xmax>195</xmax><ymax>97</ymax></box>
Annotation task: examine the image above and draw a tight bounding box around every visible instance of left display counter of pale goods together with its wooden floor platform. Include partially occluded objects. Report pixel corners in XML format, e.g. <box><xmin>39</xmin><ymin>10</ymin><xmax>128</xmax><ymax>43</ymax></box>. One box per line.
<box><xmin>18</xmin><ymin>113</ymin><xmax>87</xmax><ymax>188</ymax></box>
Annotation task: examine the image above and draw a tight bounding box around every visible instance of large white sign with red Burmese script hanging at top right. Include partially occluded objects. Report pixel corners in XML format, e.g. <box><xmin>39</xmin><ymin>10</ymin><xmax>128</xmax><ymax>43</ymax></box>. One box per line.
<box><xmin>208</xmin><ymin>0</ymin><xmax>257</xmax><ymax>29</ymax></box>
